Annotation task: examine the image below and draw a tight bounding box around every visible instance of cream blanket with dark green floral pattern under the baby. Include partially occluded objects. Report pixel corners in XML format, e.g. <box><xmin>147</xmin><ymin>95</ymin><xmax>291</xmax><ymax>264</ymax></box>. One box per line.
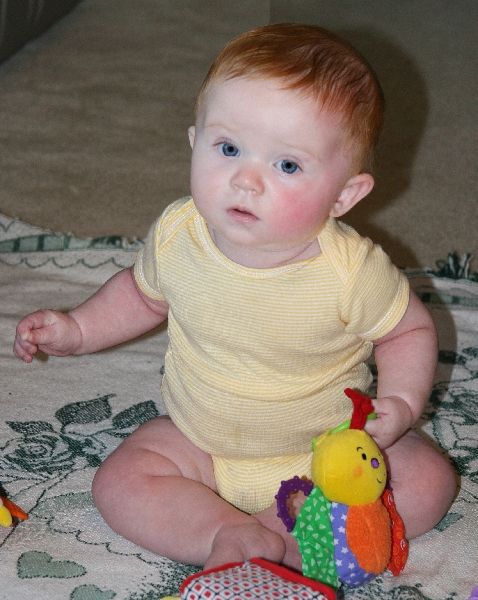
<box><xmin>0</xmin><ymin>215</ymin><xmax>478</xmax><ymax>600</ymax></box>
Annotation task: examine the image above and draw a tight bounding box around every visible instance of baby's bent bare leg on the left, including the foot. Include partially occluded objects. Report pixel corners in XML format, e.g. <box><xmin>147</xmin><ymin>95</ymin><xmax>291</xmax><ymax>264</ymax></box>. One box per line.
<box><xmin>93</xmin><ymin>417</ymin><xmax>285</xmax><ymax>568</ymax></box>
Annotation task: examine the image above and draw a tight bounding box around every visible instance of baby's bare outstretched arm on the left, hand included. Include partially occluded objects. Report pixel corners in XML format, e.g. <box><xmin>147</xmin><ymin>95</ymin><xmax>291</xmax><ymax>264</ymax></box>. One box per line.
<box><xmin>13</xmin><ymin>269</ymin><xmax>168</xmax><ymax>362</ymax></box>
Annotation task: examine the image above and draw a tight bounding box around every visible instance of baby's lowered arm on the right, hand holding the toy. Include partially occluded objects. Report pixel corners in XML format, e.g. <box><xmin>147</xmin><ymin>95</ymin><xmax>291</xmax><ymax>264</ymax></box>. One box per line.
<box><xmin>366</xmin><ymin>291</ymin><xmax>438</xmax><ymax>448</ymax></box>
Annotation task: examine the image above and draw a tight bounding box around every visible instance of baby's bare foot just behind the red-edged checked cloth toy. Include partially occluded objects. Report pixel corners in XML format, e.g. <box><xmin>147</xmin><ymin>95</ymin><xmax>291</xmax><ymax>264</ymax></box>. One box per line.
<box><xmin>204</xmin><ymin>523</ymin><xmax>285</xmax><ymax>569</ymax></box>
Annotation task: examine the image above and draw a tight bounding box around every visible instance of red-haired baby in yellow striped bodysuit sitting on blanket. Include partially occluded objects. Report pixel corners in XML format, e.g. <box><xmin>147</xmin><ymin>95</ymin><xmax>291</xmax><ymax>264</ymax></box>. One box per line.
<box><xmin>14</xmin><ymin>24</ymin><xmax>456</xmax><ymax>569</ymax></box>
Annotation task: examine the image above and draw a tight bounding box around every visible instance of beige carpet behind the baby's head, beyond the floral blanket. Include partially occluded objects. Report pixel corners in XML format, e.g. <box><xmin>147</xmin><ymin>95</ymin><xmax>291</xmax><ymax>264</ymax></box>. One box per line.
<box><xmin>0</xmin><ymin>0</ymin><xmax>478</xmax><ymax>268</ymax></box>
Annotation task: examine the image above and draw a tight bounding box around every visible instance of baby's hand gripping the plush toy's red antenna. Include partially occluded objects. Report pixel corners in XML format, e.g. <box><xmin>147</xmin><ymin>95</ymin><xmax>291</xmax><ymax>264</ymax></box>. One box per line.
<box><xmin>365</xmin><ymin>396</ymin><xmax>413</xmax><ymax>449</ymax></box>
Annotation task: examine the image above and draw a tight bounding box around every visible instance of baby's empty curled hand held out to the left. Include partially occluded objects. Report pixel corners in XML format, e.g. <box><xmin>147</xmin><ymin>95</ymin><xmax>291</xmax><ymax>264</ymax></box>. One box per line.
<box><xmin>13</xmin><ymin>310</ymin><xmax>81</xmax><ymax>363</ymax></box>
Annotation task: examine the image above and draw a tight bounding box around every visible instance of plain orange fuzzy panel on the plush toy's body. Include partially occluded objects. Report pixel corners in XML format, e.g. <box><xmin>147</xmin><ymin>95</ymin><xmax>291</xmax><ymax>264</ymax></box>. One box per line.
<box><xmin>346</xmin><ymin>499</ymin><xmax>392</xmax><ymax>575</ymax></box>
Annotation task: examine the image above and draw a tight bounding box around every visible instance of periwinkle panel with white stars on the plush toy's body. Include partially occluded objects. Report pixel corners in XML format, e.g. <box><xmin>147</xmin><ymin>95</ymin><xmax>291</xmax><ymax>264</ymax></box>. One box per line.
<box><xmin>330</xmin><ymin>502</ymin><xmax>375</xmax><ymax>586</ymax></box>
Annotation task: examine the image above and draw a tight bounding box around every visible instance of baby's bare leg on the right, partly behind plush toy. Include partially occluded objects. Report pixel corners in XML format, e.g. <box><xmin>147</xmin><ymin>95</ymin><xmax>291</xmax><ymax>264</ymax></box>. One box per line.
<box><xmin>383</xmin><ymin>431</ymin><xmax>457</xmax><ymax>539</ymax></box>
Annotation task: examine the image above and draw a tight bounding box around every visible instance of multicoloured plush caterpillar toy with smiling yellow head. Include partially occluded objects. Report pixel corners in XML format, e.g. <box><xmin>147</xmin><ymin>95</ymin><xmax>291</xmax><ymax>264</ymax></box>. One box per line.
<box><xmin>276</xmin><ymin>389</ymin><xmax>408</xmax><ymax>588</ymax></box>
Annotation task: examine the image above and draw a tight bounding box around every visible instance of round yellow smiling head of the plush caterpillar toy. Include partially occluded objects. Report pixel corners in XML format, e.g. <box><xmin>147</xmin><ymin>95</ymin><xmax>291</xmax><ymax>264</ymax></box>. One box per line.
<box><xmin>312</xmin><ymin>429</ymin><xmax>387</xmax><ymax>505</ymax></box>
